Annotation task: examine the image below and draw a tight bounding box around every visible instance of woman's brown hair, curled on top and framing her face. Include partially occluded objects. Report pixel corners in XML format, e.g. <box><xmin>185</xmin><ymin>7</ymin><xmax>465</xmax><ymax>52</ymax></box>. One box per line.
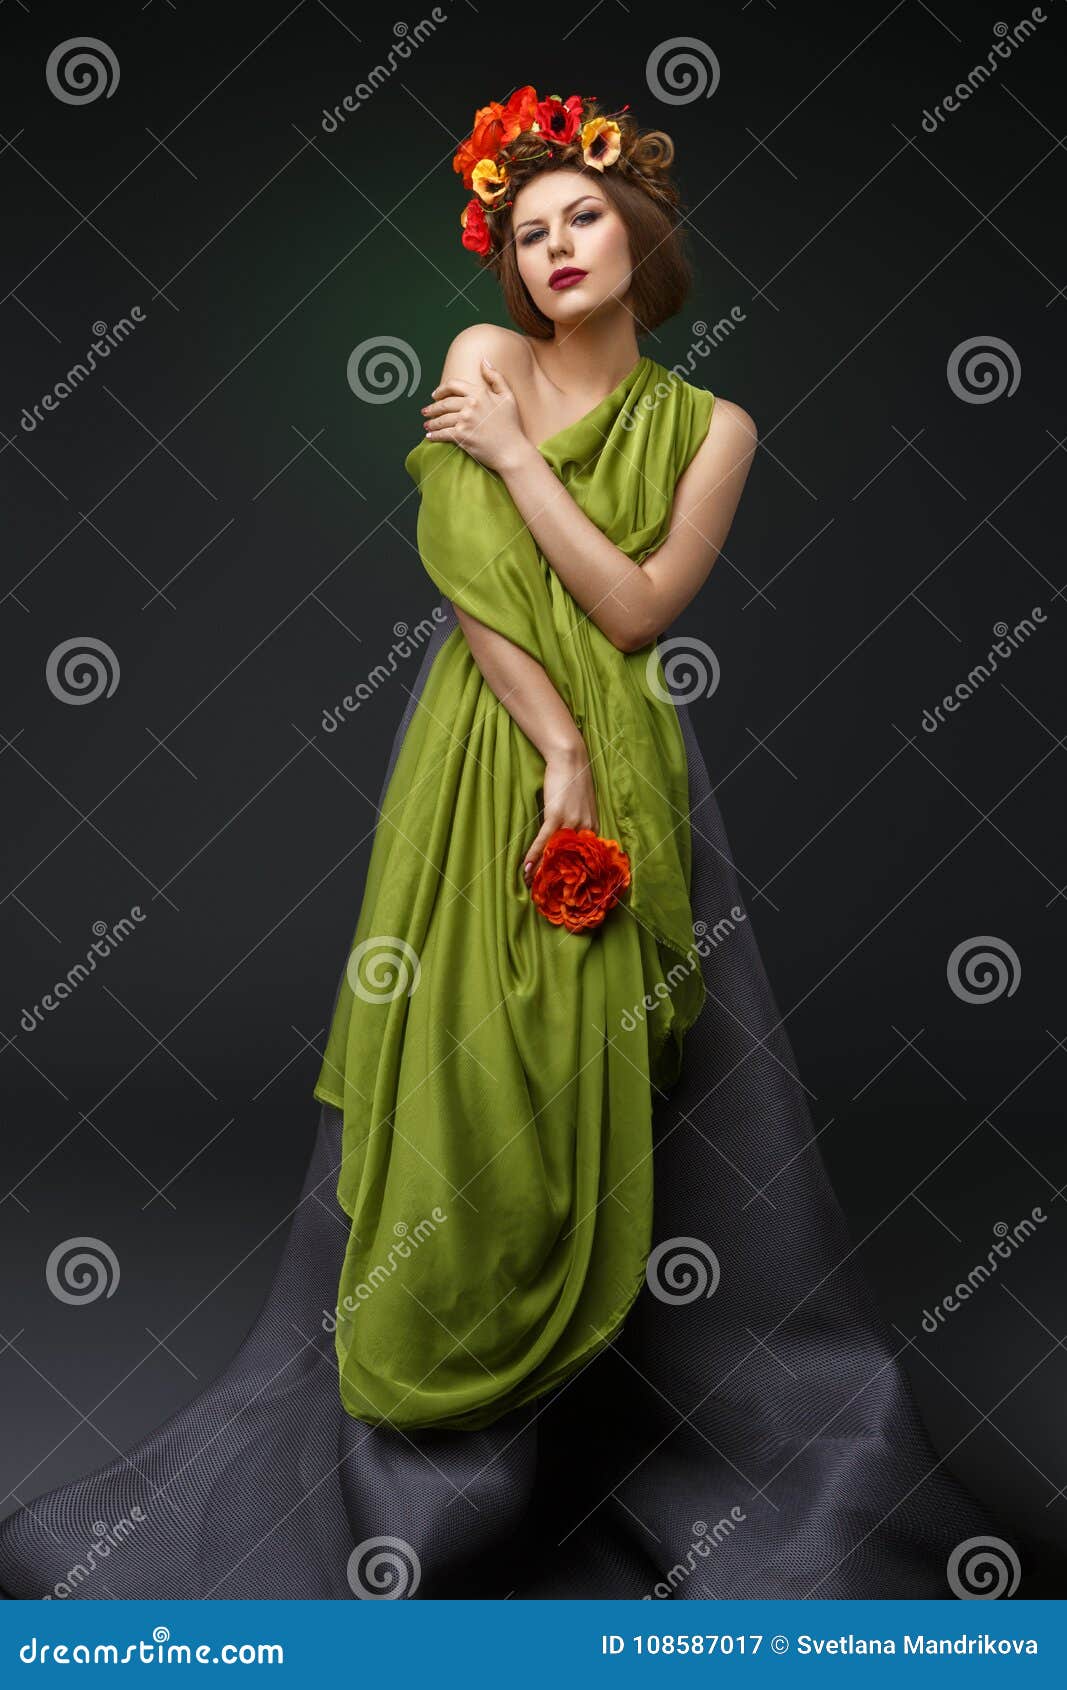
<box><xmin>480</xmin><ymin>112</ymin><xmax>693</xmax><ymax>340</ymax></box>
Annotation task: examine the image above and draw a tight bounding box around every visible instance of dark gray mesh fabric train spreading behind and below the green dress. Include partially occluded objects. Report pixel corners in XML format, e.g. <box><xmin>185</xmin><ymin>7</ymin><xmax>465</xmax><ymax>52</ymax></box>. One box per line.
<box><xmin>0</xmin><ymin>600</ymin><xmax>996</xmax><ymax>1600</ymax></box>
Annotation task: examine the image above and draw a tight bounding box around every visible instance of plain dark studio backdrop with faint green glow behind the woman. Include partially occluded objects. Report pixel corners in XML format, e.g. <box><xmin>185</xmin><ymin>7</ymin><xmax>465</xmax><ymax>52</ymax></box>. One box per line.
<box><xmin>0</xmin><ymin>0</ymin><xmax>1067</xmax><ymax>1595</ymax></box>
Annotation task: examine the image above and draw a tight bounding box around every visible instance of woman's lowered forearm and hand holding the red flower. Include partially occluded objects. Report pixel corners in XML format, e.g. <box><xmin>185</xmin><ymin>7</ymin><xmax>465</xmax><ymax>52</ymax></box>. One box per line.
<box><xmin>453</xmin><ymin>605</ymin><xmax>597</xmax><ymax>879</ymax></box>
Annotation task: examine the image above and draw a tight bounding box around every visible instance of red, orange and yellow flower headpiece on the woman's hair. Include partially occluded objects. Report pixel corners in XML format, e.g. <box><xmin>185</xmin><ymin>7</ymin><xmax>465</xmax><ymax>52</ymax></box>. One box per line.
<box><xmin>451</xmin><ymin>85</ymin><xmax>627</xmax><ymax>255</ymax></box>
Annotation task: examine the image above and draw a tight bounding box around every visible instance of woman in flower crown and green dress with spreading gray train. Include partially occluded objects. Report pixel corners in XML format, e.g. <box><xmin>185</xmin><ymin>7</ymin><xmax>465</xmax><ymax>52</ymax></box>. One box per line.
<box><xmin>0</xmin><ymin>88</ymin><xmax>1007</xmax><ymax>1599</ymax></box>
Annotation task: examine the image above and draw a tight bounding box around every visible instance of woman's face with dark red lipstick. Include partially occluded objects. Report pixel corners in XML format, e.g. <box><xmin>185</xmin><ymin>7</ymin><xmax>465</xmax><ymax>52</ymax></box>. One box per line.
<box><xmin>511</xmin><ymin>171</ymin><xmax>632</xmax><ymax>323</ymax></box>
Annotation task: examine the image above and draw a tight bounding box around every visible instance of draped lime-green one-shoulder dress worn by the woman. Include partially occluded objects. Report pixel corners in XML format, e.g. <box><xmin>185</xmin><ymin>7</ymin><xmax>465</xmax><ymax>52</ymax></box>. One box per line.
<box><xmin>315</xmin><ymin>357</ymin><xmax>714</xmax><ymax>1428</ymax></box>
